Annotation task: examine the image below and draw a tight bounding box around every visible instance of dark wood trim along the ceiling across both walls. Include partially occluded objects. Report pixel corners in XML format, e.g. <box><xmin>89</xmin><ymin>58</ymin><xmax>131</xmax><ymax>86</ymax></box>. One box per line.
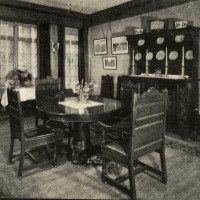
<box><xmin>0</xmin><ymin>0</ymin><xmax>197</xmax><ymax>28</ymax></box>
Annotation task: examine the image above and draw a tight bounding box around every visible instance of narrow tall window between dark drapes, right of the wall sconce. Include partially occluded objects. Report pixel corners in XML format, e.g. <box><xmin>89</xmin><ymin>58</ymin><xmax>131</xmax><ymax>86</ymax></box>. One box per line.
<box><xmin>65</xmin><ymin>28</ymin><xmax>78</xmax><ymax>89</ymax></box>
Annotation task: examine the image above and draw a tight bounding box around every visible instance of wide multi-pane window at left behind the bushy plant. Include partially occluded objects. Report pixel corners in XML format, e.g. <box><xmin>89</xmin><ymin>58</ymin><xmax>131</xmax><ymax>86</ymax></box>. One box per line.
<box><xmin>0</xmin><ymin>20</ymin><xmax>37</xmax><ymax>97</ymax></box>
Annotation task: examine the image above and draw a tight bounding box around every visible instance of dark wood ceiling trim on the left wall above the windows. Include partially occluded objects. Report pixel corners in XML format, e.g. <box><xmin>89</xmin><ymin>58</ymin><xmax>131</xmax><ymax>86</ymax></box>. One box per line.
<box><xmin>0</xmin><ymin>0</ymin><xmax>88</xmax><ymax>28</ymax></box>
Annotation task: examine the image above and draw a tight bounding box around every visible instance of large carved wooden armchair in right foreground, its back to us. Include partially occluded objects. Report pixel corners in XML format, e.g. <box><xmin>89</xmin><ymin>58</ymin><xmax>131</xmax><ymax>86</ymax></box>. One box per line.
<box><xmin>99</xmin><ymin>88</ymin><xmax>167</xmax><ymax>200</ymax></box>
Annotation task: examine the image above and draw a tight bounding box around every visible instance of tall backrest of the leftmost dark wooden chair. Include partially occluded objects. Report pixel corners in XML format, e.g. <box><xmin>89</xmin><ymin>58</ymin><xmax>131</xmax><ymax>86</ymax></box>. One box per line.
<box><xmin>7</xmin><ymin>88</ymin><xmax>24</xmax><ymax>141</ymax></box>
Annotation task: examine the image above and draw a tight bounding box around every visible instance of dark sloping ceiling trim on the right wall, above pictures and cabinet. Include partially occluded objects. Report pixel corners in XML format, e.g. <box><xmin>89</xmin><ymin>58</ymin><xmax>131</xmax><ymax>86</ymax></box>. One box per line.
<box><xmin>88</xmin><ymin>0</ymin><xmax>197</xmax><ymax>27</ymax></box>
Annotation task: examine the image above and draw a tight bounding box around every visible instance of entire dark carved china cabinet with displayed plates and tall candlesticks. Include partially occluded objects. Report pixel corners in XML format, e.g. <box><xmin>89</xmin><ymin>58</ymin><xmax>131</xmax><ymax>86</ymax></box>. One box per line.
<box><xmin>118</xmin><ymin>27</ymin><xmax>199</xmax><ymax>137</ymax></box>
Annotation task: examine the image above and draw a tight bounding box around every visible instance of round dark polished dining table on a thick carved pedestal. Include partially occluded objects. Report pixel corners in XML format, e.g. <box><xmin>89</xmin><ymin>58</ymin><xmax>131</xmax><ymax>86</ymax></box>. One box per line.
<box><xmin>36</xmin><ymin>96</ymin><xmax>121</xmax><ymax>164</ymax></box>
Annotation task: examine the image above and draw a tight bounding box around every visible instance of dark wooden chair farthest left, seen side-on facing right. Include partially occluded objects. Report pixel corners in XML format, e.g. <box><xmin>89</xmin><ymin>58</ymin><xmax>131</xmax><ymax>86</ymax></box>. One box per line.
<box><xmin>7</xmin><ymin>88</ymin><xmax>57</xmax><ymax>179</ymax></box>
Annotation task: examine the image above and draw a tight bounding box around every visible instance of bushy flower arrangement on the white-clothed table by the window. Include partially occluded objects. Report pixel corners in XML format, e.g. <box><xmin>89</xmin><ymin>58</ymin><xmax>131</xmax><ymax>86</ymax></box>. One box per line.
<box><xmin>5</xmin><ymin>69</ymin><xmax>32</xmax><ymax>86</ymax></box>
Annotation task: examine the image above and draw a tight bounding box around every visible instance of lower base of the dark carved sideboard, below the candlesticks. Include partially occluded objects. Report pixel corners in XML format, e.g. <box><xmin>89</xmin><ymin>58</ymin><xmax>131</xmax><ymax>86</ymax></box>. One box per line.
<box><xmin>117</xmin><ymin>75</ymin><xmax>198</xmax><ymax>138</ymax></box>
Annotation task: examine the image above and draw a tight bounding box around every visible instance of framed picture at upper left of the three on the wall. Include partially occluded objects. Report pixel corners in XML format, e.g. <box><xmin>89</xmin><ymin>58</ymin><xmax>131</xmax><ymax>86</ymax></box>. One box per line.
<box><xmin>94</xmin><ymin>38</ymin><xmax>107</xmax><ymax>55</ymax></box>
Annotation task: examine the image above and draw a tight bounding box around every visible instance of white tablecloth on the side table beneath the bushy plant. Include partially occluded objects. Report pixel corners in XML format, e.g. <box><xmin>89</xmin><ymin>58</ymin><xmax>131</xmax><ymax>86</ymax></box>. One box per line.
<box><xmin>1</xmin><ymin>86</ymin><xmax>35</xmax><ymax>107</ymax></box>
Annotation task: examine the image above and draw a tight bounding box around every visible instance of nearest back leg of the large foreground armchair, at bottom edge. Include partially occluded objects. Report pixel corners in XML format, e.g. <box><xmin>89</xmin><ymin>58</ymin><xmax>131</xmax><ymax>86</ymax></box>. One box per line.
<box><xmin>128</xmin><ymin>164</ymin><xmax>137</xmax><ymax>200</ymax></box>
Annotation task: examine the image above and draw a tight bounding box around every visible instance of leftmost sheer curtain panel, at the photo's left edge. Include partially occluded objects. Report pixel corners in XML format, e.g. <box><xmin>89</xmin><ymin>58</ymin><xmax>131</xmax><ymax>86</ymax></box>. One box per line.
<box><xmin>0</xmin><ymin>20</ymin><xmax>14</xmax><ymax>97</ymax></box>
